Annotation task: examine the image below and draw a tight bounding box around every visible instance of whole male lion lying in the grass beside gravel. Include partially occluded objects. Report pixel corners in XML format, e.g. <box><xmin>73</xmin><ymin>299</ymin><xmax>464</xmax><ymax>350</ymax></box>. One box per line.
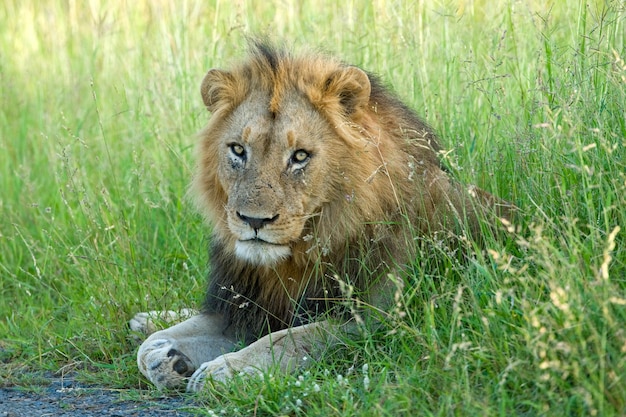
<box><xmin>131</xmin><ymin>40</ymin><xmax>513</xmax><ymax>391</ymax></box>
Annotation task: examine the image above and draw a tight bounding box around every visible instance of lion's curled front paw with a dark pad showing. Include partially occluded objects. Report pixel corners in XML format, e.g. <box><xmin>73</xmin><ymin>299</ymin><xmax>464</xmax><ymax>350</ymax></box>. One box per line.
<box><xmin>137</xmin><ymin>339</ymin><xmax>195</xmax><ymax>389</ymax></box>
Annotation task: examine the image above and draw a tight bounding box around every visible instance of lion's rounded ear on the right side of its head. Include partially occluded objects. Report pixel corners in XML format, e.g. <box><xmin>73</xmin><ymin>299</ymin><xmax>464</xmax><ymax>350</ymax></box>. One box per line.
<box><xmin>325</xmin><ymin>67</ymin><xmax>372</xmax><ymax>115</ymax></box>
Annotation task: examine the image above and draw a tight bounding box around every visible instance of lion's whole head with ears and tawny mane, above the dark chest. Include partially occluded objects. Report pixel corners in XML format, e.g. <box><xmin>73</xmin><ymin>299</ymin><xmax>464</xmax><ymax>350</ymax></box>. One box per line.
<box><xmin>196</xmin><ymin>41</ymin><xmax>446</xmax><ymax>265</ymax></box>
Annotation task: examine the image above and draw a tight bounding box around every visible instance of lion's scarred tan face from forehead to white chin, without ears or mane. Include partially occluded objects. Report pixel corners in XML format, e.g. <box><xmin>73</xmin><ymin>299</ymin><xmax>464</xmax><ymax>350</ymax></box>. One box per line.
<box><xmin>211</xmin><ymin>91</ymin><xmax>337</xmax><ymax>265</ymax></box>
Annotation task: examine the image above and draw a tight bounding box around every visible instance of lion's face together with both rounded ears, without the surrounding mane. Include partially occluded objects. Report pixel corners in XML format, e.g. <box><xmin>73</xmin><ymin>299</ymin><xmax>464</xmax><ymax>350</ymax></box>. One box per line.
<box><xmin>202</xmin><ymin>63</ymin><xmax>369</xmax><ymax>264</ymax></box>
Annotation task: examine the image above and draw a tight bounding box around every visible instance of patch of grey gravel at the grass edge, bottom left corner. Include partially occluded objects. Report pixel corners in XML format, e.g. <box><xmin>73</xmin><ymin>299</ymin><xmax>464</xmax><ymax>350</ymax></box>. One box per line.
<box><xmin>0</xmin><ymin>378</ymin><xmax>197</xmax><ymax>417</ymax></box>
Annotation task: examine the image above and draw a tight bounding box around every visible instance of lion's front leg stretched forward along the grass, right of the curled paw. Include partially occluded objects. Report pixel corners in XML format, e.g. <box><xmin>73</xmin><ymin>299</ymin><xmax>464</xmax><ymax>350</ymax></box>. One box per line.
<box><xmin>187</xmin><ymin>322</ymin><xmax>331</xmax><ymax>391</ymax></box>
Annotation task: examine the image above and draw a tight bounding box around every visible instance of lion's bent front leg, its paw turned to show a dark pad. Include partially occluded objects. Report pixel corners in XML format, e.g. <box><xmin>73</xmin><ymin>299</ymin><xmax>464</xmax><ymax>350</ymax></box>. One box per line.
<box><xmin>137</xmin><ymin>314</ymin><xmax>234</xmax><ymax>389</ymax></box>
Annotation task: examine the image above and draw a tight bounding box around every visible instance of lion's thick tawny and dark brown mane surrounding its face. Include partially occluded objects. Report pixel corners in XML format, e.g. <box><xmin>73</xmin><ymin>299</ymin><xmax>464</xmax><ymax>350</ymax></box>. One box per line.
<box><xmin>193</xmin><ymin>41</ymin><xmax>510</xmax><ymax>339</ymax></box>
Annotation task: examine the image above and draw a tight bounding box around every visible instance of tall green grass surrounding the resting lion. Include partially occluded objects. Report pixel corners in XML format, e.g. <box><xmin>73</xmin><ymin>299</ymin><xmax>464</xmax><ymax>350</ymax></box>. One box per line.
<box><xmin>0</xmin><ymin>0</ymin><xmax>626</xmax><ymax>416</ymax></box>
